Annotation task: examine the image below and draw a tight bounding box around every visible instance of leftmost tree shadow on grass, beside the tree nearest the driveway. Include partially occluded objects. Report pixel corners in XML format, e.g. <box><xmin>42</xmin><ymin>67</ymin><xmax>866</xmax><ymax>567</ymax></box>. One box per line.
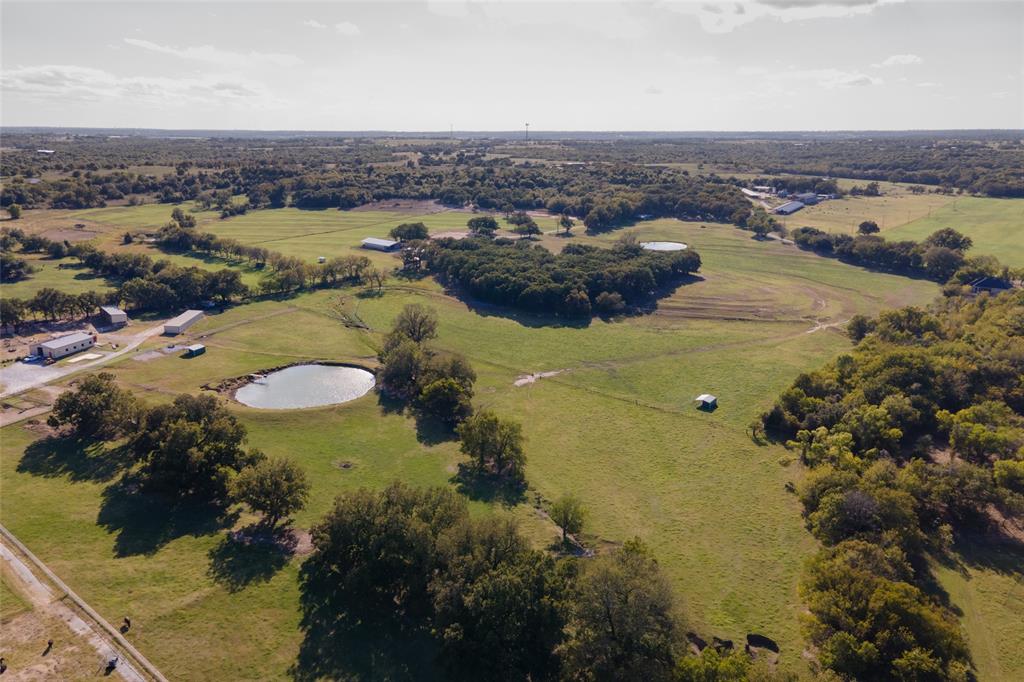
<box><xmin>17</xmin><ymin>436</ymin><xmax>132</xmax><ymax>483</ymax></box>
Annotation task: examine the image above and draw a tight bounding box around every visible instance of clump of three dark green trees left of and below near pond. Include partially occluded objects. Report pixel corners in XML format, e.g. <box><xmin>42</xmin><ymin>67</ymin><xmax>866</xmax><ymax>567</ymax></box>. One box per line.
<box><xmin>47</xmin><ymin>373</ymin><xmax>309</xmax><ymax>530</ymax></box>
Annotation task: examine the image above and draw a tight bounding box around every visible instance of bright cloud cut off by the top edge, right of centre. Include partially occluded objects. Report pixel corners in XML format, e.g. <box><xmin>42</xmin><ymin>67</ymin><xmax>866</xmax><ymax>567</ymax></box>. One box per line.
<box><xmin>658</xmin><ymin>0</ymin><xmax>903</xmax><ymax>33</ymax></box>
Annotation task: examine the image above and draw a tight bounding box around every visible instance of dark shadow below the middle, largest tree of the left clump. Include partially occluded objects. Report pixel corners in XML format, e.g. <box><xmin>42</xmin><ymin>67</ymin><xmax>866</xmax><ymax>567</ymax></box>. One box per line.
<box><xmin>96</xmin><ymin>476</ymin><xmax>239</xmax><ymax>557</ymax></box>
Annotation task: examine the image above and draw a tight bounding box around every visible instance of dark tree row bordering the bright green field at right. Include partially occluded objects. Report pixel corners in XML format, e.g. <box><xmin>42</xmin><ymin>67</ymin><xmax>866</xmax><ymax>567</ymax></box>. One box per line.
<box><xmin>791</xmin><ymin>221</ymin><xmax>972</xmax><ymax>283</ymax></box>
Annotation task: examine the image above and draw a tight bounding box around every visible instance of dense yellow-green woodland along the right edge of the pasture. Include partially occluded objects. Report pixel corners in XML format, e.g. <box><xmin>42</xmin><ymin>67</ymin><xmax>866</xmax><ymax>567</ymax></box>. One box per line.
<box><xmin>763</xmin><ymin>291</ymin><xmax>1024</xmax><ymax>680</ymax></box>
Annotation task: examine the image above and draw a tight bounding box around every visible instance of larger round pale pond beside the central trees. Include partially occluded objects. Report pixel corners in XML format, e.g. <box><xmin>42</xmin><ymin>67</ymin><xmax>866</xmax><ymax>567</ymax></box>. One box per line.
<box><xmin>234</xmin><ymin>365</ymin><xmax>375</xmax><ymax>410</ymax></box>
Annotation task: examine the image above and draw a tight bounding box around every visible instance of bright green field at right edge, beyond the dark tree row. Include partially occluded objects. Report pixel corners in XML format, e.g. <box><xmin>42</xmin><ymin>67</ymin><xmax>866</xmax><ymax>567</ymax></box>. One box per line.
<box><xmin>880</xmin><ymin>197</ymin><xmax>1024</xmax><ymax>267</ymax></box>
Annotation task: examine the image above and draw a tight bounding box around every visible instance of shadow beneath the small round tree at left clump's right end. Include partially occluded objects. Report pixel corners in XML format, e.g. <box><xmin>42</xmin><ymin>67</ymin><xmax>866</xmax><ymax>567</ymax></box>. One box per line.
<box><xmin>207</xmin><ymin>526</ymin><xmax>295</xmax><ymax>593</ymax></box>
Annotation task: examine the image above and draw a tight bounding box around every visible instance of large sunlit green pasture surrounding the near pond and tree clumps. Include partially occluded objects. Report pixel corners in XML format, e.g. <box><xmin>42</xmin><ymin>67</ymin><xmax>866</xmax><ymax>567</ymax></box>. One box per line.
<box><xmin>0</xmin><ymin>210</ymin><xmax>937</xmax><ymax>680</ymax></box>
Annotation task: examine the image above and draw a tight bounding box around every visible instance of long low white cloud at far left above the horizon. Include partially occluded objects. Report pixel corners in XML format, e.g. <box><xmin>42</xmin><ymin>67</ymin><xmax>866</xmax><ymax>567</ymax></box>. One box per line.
<box><xmin>0</xmin><ymin>65</ymin><xmax>271</xmax><ymax>105</ymax></box>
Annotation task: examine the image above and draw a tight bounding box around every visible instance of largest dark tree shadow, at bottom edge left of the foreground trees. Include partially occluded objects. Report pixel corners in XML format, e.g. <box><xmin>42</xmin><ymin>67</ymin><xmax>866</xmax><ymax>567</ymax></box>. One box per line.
<box><xmin>289</xmin><ymin>556</ymin><xmax>441</xmax><ymax>682</ymax></box>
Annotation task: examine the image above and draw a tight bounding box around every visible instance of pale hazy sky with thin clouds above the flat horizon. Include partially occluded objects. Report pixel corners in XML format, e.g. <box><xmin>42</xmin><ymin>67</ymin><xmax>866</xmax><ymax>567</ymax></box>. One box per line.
<box><xmin>0</xmin><ymin>0</ymin><xmax>1024</xmax><ymax>130</ymax></box>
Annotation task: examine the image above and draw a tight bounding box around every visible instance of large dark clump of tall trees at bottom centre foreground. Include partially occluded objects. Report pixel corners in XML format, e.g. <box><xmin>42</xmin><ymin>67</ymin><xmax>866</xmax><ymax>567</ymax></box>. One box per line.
<box><xmin>302</xmin><ymin>483</ymin><xmax>765</xmax><ymax>682</ymax></box>
